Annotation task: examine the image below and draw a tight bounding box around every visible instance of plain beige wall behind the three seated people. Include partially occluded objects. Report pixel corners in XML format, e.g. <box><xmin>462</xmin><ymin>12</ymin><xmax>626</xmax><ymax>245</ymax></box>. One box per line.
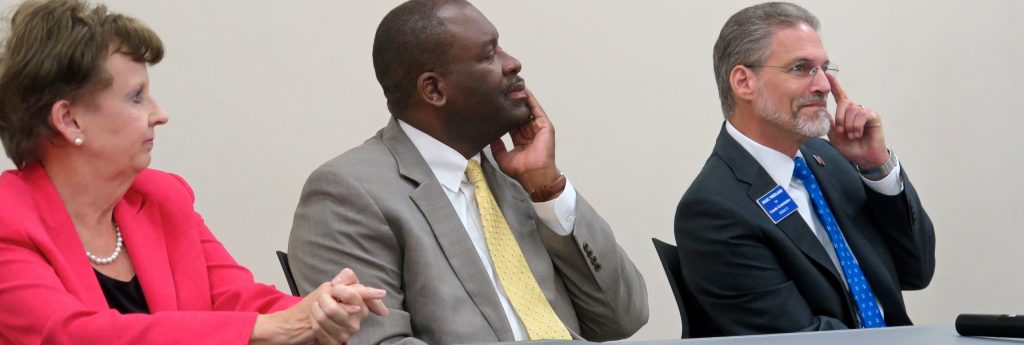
<box><xmin>0</xmin><ymin>0</ymin><xmax>1024</xmax><ymax>339</ymax></box>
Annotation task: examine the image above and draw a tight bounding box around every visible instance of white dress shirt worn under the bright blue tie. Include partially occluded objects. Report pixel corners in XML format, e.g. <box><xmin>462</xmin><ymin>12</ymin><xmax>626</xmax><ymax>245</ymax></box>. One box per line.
<box><xmin>725</xmin><ymin>121</ymin><xmax>903</xmax><ymax>317</ymax></box>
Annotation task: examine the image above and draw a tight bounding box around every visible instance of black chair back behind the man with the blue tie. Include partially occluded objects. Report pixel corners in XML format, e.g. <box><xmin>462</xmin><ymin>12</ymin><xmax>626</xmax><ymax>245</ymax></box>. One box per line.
<box><xmin>650</xmin><ymin>239</ymin><xmax>722</xmax><ymax>338</ymax></box>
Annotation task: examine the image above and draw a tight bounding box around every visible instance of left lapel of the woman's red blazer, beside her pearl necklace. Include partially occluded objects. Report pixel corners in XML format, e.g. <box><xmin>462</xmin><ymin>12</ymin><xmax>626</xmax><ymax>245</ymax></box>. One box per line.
<box><xmin>23</xmin><ymin>165</ymin><xmax>109</xmax><ymax>309</ymax></box>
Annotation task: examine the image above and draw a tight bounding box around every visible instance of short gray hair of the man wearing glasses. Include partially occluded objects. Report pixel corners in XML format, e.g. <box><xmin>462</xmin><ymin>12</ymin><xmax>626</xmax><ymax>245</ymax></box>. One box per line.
<box><xmin>713</xmin><ymin>2</ymin><xmax>818</xmax><ymax>120</ymax></box>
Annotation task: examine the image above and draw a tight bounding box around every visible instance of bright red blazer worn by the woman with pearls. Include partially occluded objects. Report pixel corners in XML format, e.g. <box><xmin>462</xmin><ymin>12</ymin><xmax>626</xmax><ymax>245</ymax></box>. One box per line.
<box><xmin>0</xmin><ymin>165</ymin><xmax>299</xmax><ymax>344</ymax></box>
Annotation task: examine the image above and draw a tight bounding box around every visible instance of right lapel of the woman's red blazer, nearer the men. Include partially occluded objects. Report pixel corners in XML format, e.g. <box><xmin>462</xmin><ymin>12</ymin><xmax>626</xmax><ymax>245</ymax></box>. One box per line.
<box><xmin>114</xmin><ymin>189</ymin><xmax>178</xmax><ymax>313</ymax></box>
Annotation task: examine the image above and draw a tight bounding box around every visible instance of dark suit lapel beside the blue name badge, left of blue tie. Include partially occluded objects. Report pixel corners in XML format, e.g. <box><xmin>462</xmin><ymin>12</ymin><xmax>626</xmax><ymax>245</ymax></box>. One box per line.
<box><xmin>715</xmin><ymin>126</ymin><xmax>842</xmax><ymax>282</ymax></box>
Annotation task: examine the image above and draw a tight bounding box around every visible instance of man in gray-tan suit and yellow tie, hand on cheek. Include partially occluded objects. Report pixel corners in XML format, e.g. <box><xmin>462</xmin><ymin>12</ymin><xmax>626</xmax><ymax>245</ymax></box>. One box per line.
<box><xmin>289</xmin><ymin>0</ymin><xmax>647</xmax><ymax>344</ymax></box>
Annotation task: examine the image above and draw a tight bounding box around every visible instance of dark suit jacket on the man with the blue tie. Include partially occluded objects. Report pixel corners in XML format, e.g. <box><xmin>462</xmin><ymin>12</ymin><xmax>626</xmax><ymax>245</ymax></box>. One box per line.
<box><xmin>676</xmin><ymin>127</ymin><xmax>935</xmax><ymax>335</ymax></box>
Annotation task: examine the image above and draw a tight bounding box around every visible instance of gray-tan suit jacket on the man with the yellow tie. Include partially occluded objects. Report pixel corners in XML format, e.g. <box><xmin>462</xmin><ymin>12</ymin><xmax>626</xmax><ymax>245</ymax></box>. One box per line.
<box><xmin>288</xmin><ymin>120</ymin><xmax>647</xmax><ymax>344</ymax></box>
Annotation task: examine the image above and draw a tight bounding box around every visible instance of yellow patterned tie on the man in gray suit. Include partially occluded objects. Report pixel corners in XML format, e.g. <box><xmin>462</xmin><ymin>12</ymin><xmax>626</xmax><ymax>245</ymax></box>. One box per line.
<box><xmin>466</xmin><ymin>160</ymin><xmax>572</xmax><ymax>340</ymax></box>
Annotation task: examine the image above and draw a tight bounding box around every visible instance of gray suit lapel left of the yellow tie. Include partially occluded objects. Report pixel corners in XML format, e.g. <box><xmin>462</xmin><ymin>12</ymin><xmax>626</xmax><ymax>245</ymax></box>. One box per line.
<box><xmin>382</xmin><ymin>119</ymin><xmax>514</xmax><ymax>341</ymax></box>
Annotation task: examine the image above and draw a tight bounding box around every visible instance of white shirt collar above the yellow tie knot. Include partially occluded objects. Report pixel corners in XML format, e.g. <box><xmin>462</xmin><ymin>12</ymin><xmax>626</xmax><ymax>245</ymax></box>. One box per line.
<box><xmin>398</xmin><ymin>120</ymin><xmax>480</xmax><ymax>192</ymax></box>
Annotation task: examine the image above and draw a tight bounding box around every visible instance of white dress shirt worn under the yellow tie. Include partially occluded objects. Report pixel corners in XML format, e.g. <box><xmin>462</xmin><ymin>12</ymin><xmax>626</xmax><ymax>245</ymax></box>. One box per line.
<box><xmin>398</xmin><ymin>120</ymin><xmax>577</xmax><ymax>341</ymax></box>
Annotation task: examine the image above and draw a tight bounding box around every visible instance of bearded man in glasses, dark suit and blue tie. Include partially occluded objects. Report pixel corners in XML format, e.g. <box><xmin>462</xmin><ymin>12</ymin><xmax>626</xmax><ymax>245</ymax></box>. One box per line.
<box><xmin>676</xmin><ymin>3</ymin><xmax>935</xmax><ymax>335</ymax></box>
